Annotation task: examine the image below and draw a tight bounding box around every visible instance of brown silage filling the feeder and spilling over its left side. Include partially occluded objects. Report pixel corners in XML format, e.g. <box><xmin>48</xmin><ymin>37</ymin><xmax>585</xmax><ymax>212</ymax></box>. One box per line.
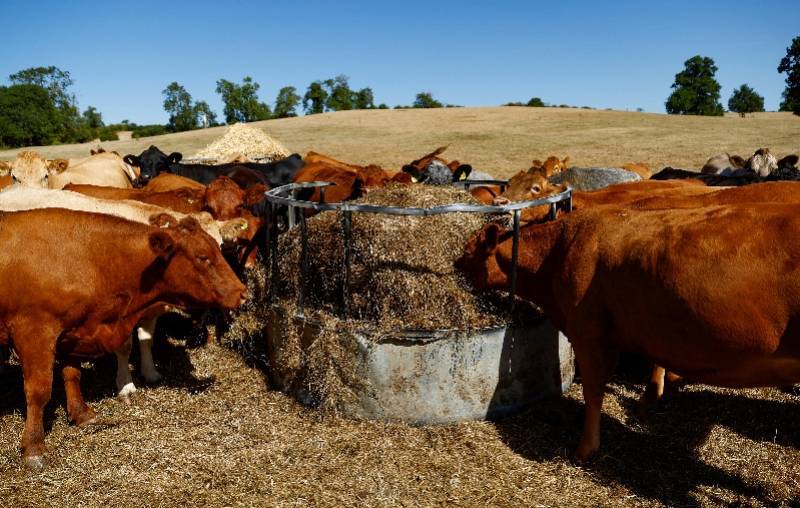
<box><xmin>219</xmin><ymin>185</ymin><xmax>508</xmax><ymax>413</ymax></box>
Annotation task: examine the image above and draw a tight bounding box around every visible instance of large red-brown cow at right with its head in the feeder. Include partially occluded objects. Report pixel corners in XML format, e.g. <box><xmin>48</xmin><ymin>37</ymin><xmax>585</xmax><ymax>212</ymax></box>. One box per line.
<box><xmin>457</xmin><ymin>204</ymin><xmax>800</xmax><ymax>460</ymax></box>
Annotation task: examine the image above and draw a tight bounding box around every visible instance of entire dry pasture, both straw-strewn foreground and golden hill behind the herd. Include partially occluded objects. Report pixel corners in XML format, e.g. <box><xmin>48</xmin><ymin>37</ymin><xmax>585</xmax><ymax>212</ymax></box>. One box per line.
<box><xmin>0</xmin><ymin>108</ymin><xmax>800</xmax><ymax>507</ymax></box>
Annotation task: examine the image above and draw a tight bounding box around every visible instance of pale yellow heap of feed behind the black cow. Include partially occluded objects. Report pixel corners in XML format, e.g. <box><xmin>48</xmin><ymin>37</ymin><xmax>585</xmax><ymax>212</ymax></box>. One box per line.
<box><xmin>192</xmin><ymin>123</ymin><xmax>290</xmax><ymax>162</ymax></box>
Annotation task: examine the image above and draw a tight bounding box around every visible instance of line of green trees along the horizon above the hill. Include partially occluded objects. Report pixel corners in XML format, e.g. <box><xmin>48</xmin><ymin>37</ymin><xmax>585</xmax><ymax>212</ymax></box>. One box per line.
<box><xmin>0</xmin><ymin>36</ymin><xmax>800</xmax><ymax>147</ymax></box>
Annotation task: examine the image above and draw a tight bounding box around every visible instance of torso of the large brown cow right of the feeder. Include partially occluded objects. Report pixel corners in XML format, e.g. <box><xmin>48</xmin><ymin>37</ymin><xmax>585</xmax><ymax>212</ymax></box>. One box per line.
<box><xmin>553</xmin><ymin>204</ymin><xmax>800</xmax><ymax>380</ymax></box>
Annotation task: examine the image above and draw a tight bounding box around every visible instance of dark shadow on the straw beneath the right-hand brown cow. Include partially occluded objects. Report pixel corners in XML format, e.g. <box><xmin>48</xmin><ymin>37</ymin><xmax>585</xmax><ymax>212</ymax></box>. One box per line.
<box><xmin>495</xmin><ymin>376</ymin><xmax>800</xmax><ymax>506</ymax></box>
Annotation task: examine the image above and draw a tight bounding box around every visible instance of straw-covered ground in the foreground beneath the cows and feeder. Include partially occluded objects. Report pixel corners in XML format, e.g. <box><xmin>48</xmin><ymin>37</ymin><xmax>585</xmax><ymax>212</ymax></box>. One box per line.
<box><xmin>0</xmin><ymin>340</ymin><xmax>800</xmax><ymax>507</ymax></box>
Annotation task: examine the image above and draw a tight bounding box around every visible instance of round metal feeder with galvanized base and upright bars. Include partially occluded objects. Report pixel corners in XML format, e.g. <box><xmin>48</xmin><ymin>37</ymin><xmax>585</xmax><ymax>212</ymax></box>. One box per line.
<box><xmin>265</xmin><ymin>182</ymin><xmax>574</xmax><ymax>424</ymax></box>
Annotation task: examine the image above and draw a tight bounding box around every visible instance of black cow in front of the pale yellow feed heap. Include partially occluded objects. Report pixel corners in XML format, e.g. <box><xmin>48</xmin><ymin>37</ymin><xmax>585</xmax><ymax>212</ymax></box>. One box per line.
<box><xmin>123</xmin><ymin>145</ymin><xmax>304</xmax><ymax>189</ymax></box>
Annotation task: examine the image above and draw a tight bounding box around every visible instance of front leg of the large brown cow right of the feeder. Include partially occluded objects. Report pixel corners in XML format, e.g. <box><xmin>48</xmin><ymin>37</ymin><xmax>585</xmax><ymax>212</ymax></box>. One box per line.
<box><xmin>573</xmin><ymin>338</ymin><xmax>618</xmax><ymax>461</ymax></box>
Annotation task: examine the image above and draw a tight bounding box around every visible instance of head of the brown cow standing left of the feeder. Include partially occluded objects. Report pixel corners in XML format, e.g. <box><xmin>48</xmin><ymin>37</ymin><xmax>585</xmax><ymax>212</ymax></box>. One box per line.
<box><xmin>149</xmin><ymin>214</ymin><xmax>246</xmax><ymax>309</ymax></box>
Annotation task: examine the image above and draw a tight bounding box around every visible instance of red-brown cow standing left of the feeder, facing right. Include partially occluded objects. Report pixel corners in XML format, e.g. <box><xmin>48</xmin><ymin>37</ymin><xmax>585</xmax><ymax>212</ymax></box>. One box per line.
<box><xmin>0</xmin><ymin>209</ymin><xmax>245</xmax><ymax>468</ymax></box>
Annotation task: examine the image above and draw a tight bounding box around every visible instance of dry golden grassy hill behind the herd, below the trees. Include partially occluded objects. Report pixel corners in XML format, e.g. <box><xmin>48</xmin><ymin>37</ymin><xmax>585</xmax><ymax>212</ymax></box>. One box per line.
<box><xmin>0</xmin><ymin>107</ymin><xmax>800</xmax><ymax>177</ymax></box>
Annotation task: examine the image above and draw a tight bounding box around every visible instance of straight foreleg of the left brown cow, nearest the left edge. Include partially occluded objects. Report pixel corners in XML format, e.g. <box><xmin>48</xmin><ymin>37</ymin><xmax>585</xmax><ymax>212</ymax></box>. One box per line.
<box><xmin>14</xmin><ymin>330</ymin><xmax>56</xmax><ymax>470</ymax></box>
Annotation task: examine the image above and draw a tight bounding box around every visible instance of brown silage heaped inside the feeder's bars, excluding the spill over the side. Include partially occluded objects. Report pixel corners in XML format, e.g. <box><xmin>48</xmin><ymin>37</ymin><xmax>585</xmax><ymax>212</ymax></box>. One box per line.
<box><xmin>278</xmin><ymin>185</ymin><xmax>502</xmax><ymax>335</ymax></box>
